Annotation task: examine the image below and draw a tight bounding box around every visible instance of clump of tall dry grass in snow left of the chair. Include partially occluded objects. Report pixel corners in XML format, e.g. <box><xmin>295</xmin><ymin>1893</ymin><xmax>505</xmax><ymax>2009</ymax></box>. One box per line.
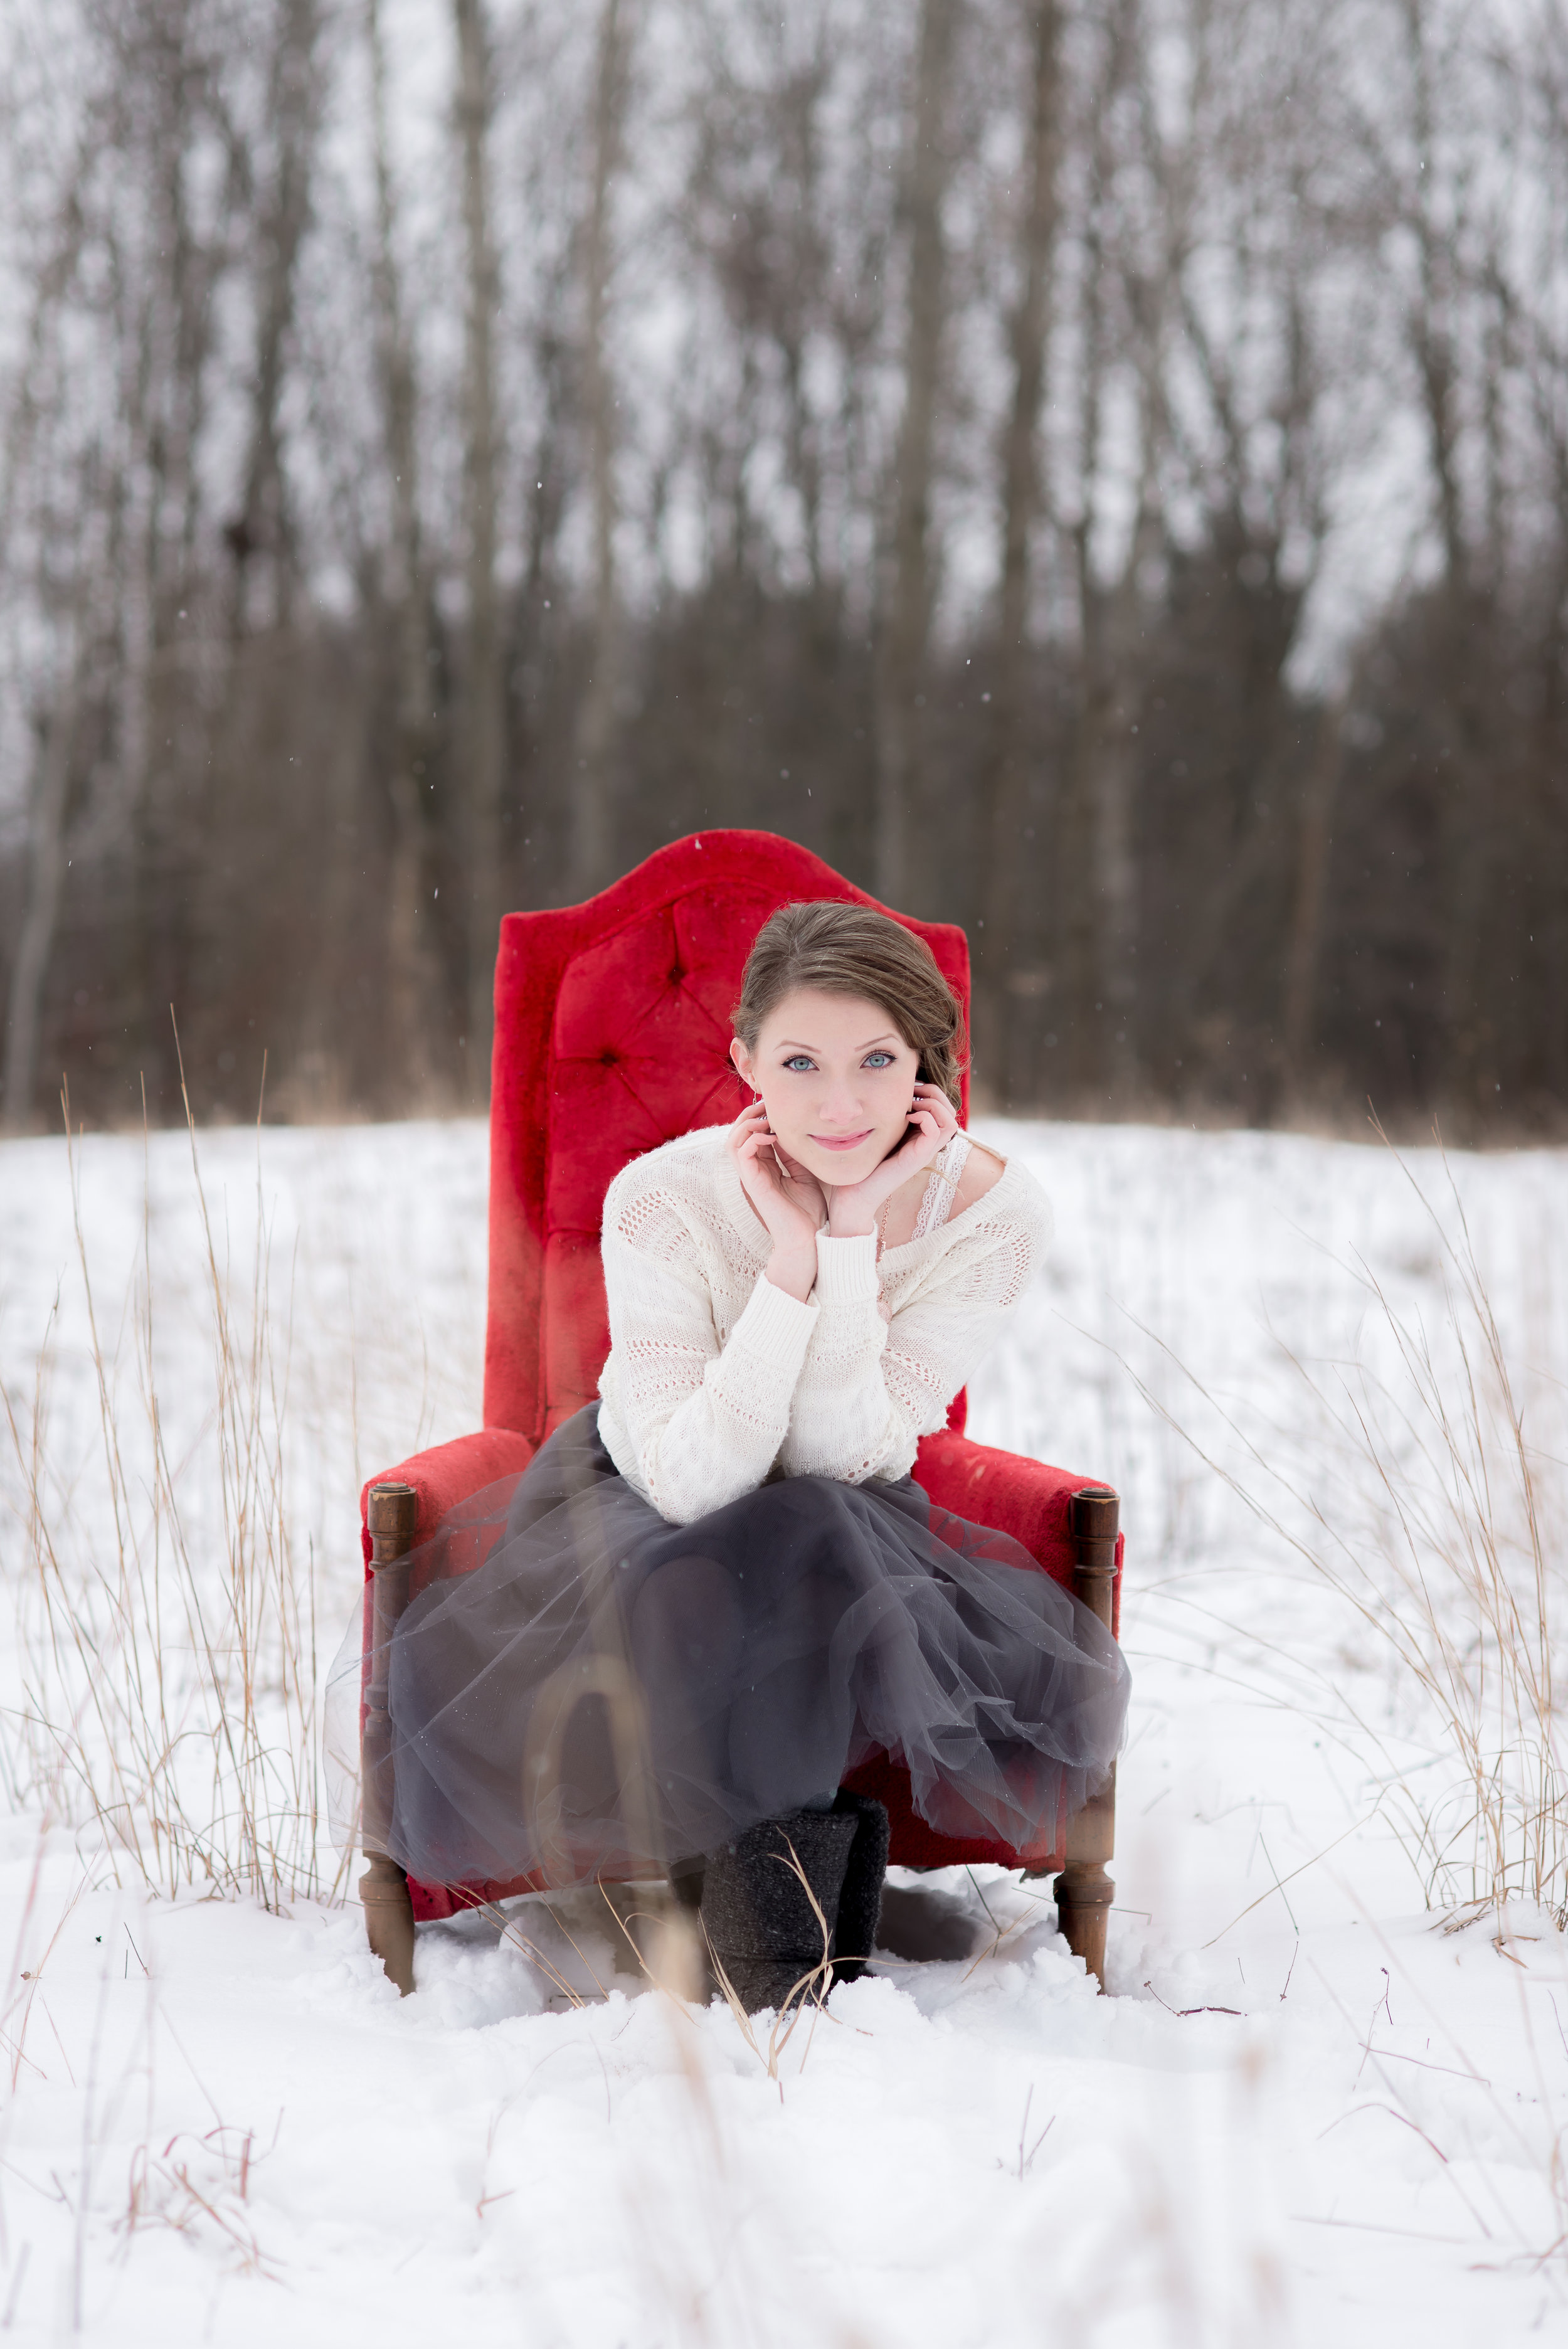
<box><xmin>4</xmin><ymin>1066</ymin><xmax>322</xmax><ymax>1907</ymax></box>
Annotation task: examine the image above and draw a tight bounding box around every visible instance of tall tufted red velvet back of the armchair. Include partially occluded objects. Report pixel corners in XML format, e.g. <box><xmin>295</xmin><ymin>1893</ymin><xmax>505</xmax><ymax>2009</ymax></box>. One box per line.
<box><xmin>484</xmin><ymin>832</ymin><xmax>970</xmax><ymax>1442</ymax></box>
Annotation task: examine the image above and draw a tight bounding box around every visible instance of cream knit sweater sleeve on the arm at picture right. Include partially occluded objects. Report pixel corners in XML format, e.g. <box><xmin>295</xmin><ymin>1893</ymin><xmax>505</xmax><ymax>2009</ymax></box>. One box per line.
<box><xmin>781</xmin><ymin>1182</ymin><xmax>1052</xmax><ymax>1485</ymax></box>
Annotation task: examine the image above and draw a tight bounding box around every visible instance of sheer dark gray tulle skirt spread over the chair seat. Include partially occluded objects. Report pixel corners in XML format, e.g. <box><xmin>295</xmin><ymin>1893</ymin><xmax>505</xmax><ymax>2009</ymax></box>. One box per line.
<box><xmin>333</xmin><ymin>1405</ymin><xmax>1129</xmax><ymax>1884</ymax></box>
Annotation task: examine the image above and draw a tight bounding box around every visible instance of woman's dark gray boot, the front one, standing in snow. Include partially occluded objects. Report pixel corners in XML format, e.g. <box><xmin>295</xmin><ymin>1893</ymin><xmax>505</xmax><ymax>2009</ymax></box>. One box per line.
<box><xmin>702</xmin><ymin>1809</ymin><xmax>862</xmax><ymax>2015</ymax></box>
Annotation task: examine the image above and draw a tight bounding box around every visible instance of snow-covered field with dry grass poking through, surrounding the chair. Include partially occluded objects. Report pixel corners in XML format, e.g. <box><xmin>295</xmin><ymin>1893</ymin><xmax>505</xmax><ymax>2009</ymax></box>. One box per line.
<box><xmin>0</xmin><ymin>1123</ymin><xmax>1568</xmax><ymax>2349</ymax></box>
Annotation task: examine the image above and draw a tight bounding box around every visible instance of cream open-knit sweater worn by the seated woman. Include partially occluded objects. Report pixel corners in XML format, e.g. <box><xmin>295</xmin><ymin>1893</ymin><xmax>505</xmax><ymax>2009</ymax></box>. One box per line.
<box><xmin>598</xmin><ymin>1125</ymin><xmax>1052</xmax><ymax>1525</ymax></box>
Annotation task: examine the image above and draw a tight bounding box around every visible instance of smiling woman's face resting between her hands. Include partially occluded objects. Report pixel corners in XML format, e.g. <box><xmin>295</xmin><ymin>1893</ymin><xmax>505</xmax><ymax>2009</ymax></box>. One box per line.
<box><xmin>730</xmin><ymin>987</ymin><xmax>920</xmax><ymax>1184</ymax></box>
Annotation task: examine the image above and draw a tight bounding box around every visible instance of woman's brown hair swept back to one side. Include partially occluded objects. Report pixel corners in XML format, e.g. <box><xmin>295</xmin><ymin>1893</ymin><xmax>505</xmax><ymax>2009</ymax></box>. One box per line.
<box><xmin>730</xmin><ymin>898</ymin><xmax>967</xmax><ymax>1109</ymax></box>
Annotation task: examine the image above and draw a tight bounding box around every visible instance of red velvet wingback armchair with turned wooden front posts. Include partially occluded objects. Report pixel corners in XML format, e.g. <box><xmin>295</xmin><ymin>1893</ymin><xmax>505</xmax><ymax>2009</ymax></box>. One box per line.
<box><xmin>361</xmin><ymin>832</ymin><xmax>1122</xmax><ymax>1992</ymax></box>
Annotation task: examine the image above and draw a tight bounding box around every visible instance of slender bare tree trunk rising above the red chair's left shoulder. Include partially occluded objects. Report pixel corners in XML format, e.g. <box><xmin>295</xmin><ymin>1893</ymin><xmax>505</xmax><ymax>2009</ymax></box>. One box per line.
<box><xmin>570</xmin><ymin>0</ymin><xmax>632</xmax><ymax>898</ymax></box>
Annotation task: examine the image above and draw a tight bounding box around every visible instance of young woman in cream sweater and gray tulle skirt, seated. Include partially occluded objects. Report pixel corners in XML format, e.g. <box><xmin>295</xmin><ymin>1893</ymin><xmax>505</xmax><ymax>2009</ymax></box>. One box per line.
<box><xmin>364</xmin><ymin>904</ymin><xmax>1126</xmax><ymax>2008</ymax></box>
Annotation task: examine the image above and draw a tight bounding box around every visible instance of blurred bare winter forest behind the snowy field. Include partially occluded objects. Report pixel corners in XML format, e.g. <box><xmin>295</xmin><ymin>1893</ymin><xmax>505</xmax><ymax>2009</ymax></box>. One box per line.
<box><xmin>0</xmin><ymin>0</ymin><xmax>1568</xmax><ymax>1139</ymax></box>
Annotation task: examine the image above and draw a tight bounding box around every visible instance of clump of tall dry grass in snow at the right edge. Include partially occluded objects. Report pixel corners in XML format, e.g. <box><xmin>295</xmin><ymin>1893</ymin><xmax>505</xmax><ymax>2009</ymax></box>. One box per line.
<box><xmin>1131</xmin><ymin>1128</ymin><xmax>1568</xmax><ymax>1929</ymax></box>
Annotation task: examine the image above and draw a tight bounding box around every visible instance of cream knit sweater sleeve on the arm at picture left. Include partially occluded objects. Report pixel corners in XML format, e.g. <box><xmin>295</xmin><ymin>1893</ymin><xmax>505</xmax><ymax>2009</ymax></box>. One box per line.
<box><xmin>601</xmin><ymin>1170</ymin><xmax>817</xmax><ymax>1525</ymax></box>
